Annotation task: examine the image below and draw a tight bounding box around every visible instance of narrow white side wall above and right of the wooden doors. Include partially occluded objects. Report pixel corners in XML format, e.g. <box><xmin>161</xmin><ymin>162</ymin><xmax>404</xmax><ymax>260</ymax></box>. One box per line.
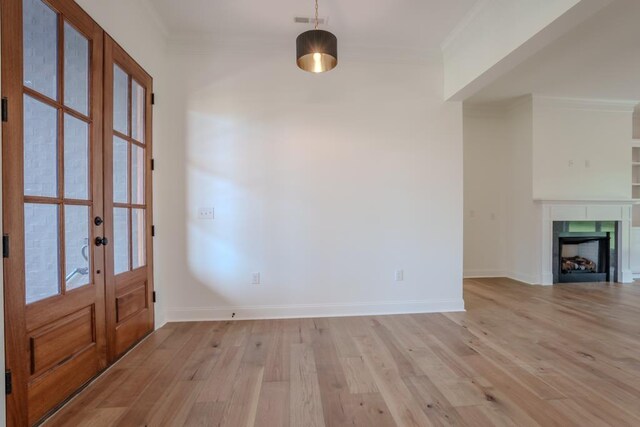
<box><xmin>77</xmin><ymin>0</ymin><xmax>169</xmax><ymax>326</ymax></box>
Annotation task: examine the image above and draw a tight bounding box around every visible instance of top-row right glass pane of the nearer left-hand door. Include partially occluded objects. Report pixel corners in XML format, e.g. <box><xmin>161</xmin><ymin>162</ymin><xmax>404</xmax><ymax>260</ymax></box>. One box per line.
<box><xmin>64</xmin><ymin>22</ymin><xmax>89</xmax><ymax>116</ymax></box>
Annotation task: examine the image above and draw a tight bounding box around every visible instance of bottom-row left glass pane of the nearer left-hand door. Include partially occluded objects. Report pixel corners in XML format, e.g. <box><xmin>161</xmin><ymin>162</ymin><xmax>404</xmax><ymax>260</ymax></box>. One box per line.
<box><xmin>24</xmin><ymin>203</ymin><xmax>60</xmax><ymax>304</ymax></box>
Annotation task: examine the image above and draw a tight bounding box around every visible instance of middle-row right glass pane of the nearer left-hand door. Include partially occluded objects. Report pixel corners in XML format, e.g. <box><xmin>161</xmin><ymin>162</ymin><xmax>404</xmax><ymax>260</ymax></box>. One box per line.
<box><xmin>64</xmin><ymin>114</ymin><xmax>89</xmax><ymax>200</ymax></box>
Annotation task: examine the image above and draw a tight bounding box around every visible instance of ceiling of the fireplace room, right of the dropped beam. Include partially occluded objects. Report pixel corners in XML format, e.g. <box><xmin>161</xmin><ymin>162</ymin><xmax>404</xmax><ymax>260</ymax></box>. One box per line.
<box><xmin>468</xmin><ymin>0</ymin><xmax>640</xmax><ymax>103</ymax></box>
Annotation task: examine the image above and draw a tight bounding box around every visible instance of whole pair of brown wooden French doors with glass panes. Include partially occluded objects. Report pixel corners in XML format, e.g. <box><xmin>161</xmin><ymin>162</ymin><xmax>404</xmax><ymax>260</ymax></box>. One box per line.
<box><xmin>1</xmin><ymin>0</ymin><xmax>153</xmax><ymax>426</ymax></box>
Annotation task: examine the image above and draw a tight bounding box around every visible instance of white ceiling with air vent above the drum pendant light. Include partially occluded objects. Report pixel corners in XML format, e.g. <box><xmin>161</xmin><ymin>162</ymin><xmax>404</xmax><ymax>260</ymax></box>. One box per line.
<box><xmin>149</xmin><ymin>0</ymin><xmax>476</xmax><ymax>52</ymax></box>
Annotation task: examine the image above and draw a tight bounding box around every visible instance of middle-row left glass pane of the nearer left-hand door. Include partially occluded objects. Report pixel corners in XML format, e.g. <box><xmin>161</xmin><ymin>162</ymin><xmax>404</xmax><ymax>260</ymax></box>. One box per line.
<box><xmin>24</xmin><ymin>95</ymin><xmax>58</xmax><ymax>197</ymax></box>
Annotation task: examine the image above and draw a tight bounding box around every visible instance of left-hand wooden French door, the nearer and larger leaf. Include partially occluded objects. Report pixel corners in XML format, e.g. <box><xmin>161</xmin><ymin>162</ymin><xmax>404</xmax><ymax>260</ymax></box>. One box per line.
<box><xmin>1</xmin><ymin>0</ymin><xmax>107</xmax><ymax>426</ymax></box>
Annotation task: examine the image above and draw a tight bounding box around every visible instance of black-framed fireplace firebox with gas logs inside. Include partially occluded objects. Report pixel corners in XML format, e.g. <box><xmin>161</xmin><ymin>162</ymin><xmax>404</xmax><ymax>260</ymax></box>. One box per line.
<box><xmin>556</xmin><ymin>232</ymin><xmax>611</xmax><ymax>283</ymax></box>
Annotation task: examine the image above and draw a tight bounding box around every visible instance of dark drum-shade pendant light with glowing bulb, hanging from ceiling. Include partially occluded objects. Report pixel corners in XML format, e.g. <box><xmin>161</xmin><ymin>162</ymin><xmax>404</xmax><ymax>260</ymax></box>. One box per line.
<box><xmin>296</xmin><ymin>0</ymin><xmax>338</xmax><ymax>73</ymax></box>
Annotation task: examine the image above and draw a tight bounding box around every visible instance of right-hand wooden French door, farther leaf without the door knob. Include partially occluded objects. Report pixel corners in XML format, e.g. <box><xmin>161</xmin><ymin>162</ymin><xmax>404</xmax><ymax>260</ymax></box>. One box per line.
<box><xmin>104</xmin><ymin>35</ymin><xmax>154</xmax><ymax>361</ymax></box>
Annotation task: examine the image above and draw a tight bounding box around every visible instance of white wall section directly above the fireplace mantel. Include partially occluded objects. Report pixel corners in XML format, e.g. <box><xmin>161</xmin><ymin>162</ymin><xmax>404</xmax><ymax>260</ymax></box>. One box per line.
<box><xmin>533</xmin><ymin>97</ymin><xmax>633</xmax><ymax>200</ymax></box>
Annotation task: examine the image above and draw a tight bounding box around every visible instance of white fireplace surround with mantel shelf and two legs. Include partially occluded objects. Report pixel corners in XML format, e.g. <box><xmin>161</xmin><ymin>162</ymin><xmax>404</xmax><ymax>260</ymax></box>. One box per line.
<box><xmin>536</xmin><ymin>200</ymin><xmax>634</xmax><ymax>285</ymax></box>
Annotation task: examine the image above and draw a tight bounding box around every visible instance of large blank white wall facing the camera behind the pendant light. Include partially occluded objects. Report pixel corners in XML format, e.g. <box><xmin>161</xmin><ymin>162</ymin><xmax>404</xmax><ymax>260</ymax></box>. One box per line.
<box><xmin>163</xmin><ymin>47</ymin><xmax>463</xmax><ymax>320</ymax></box>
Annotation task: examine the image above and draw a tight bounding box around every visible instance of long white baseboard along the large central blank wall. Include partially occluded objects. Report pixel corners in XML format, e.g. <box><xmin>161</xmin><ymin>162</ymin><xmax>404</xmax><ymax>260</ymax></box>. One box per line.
<box><xmin>166</xmin><ymin>299</ymin><xmax>465</xmax><ymax>322</ymax></box>
